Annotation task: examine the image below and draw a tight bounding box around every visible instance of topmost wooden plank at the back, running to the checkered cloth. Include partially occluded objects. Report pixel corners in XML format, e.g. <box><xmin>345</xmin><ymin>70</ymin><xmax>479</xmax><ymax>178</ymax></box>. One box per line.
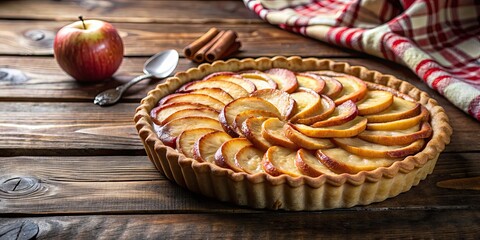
<box><xmin>0</xmin><ymin>0</ymin><xmax>261</xmax><ymax>23</ymax></box>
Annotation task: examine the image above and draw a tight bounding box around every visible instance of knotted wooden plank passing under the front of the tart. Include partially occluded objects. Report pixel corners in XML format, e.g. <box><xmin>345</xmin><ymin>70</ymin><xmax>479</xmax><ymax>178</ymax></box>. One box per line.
<box><xmin>0</xmin><ymin>153</ymin><xmax>480</xmax><ymax>215</ymax></box>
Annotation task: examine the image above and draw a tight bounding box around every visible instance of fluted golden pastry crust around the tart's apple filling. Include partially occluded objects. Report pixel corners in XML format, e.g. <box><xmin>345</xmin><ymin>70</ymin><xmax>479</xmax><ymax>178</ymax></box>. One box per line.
<box><xmin>134</xmin><ymin>57</ymin><xmax>452</xmax><ymax>211</ymax></box>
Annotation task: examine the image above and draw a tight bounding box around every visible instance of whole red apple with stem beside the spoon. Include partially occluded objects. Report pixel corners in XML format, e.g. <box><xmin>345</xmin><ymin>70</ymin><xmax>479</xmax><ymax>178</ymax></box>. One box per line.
<box><xmin>53</xmin><ymin>17</ymin><xmax>123</xmax><ymax>82</ymax></box>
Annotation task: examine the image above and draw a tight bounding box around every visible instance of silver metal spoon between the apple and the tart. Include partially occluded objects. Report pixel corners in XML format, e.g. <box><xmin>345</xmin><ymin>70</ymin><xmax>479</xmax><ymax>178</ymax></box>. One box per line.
<box><xmin>93</xmin><ymin>49</ymin><xmax>178</xmax><ymax>106</ymax></box>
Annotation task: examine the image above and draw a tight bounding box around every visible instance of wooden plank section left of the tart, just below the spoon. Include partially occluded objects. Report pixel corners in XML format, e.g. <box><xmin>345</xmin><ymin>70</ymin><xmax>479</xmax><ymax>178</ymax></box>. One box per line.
<box><xmin>0</xmin><ymin>102</ymin><xmax>145</xmax><ymax>156</ymax></box>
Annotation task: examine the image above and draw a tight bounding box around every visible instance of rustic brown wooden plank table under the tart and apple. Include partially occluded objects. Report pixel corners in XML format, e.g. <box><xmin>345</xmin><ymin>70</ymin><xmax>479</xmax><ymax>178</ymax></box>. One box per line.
<box><xmin>0</xmin><ymin>0</ymin><xmax>480</xmax><ymax>239</ymax></box>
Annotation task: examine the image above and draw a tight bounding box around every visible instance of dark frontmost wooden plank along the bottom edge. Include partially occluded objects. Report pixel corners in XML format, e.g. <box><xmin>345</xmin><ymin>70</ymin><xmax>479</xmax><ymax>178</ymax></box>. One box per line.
<box><xmin>0</xmin><ymin>210</ymin><xmax>480</xmax><ymax>239</ymax></box>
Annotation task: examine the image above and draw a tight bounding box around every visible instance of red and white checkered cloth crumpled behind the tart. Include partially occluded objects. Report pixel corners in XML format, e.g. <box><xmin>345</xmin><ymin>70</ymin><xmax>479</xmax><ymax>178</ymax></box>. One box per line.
<box><xmin>244</xmin><ymin>0</ymin><xmax>480</xmax><ymax>121</ymax></box>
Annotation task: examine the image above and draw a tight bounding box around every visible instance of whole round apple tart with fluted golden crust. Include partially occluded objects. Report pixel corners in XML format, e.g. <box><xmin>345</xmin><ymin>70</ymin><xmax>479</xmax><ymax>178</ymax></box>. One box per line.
<box><xmin>135</xmin><ymin>57</ymin><xmax>452</xmax><ymax>210</ymax></box>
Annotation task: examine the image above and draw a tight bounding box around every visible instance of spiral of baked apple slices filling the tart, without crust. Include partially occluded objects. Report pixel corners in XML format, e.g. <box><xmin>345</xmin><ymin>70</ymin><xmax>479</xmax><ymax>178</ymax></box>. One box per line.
<box><xmin>151</xmin><ymin>68</ymin><xmax>432</xmax><ymax>177</ymax></box>
